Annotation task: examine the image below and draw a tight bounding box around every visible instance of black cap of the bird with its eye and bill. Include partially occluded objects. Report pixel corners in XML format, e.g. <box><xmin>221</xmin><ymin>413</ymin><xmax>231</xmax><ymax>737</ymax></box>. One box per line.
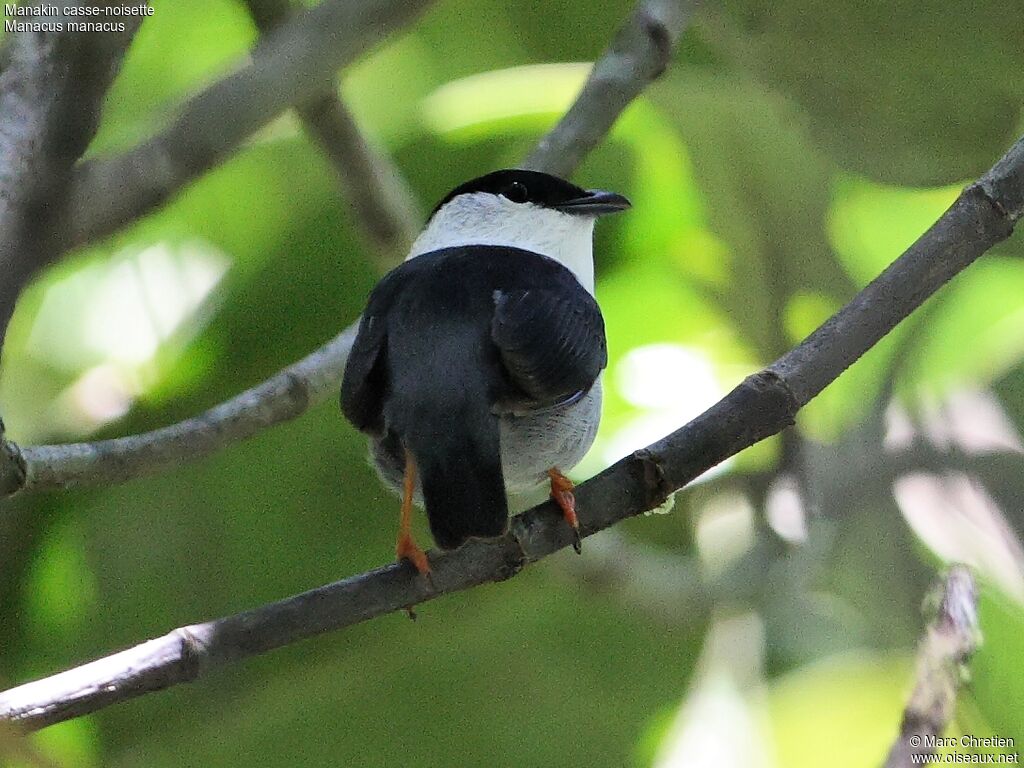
<box><xmin>430</xmin><ymin>168</ymin><xmax>630</xmax><ymax>216</ymax></box>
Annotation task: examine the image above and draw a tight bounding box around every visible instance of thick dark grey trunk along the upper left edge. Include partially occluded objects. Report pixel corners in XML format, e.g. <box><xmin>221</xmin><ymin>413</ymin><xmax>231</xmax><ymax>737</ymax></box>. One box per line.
<box><xmin>0</xmin><ymin>2</ymin><xmax>141</xmax><ymax>339</ymax></box>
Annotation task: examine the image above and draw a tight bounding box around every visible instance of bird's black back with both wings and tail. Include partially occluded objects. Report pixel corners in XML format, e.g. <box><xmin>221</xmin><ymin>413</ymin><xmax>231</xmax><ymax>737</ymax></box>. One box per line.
<box><xmin>341</xmin><ymin>246</ymin><xmax>607</xmax><ymax>548</ymax></box>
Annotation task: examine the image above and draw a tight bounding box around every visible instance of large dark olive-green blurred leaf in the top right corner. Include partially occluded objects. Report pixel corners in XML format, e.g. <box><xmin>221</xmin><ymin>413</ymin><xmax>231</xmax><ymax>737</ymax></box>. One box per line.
<box><xmin>707</xmin><ymin>0</ymin><xmax>1024</xmax><ymax>185</ymax></box>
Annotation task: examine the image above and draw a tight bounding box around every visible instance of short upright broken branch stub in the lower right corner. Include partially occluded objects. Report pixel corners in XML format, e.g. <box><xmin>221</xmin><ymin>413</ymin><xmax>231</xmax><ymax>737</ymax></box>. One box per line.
<box><xmin>886</xmin><ymin>565</ymin><xmax>981</xmax><ymax>768</ymax></box>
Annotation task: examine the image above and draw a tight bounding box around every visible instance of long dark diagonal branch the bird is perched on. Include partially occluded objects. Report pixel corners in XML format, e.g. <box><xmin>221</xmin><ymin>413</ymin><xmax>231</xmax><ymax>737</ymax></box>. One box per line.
<box><xmin>0</xmin><ymin>134</ymin><xmax>1024</xmax><ymax>729</ymax></box>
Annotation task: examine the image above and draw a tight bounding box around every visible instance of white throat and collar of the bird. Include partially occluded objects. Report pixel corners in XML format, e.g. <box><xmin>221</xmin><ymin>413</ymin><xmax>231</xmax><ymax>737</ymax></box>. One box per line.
<box><xmin>406</xmin><ymin>193</ymin><xmax>594</xmax><ymax>294</ymax></box>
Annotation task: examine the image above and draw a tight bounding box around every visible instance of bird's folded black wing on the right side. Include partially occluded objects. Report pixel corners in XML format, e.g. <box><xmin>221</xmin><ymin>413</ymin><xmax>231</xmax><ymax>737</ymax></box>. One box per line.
<box><xmin>490</xmin><ymin>280</ymin><xmax>608</xmax><ymax>402</ymax></box>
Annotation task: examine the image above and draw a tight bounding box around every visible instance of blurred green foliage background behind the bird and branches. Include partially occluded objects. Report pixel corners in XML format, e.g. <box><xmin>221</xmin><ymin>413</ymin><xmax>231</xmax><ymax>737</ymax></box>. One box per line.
<box><xmin>0</xmin><ymin>0</ymin><xmax>1024</xmax><ymax>768</ymax></box>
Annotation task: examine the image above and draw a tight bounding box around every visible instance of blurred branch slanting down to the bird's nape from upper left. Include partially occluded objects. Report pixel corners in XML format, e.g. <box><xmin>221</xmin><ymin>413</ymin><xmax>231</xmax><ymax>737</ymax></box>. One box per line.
<box><xmin>247</xmin><ymin>0</ymin><xmax>422</xmax><ymax>268</ymax></box>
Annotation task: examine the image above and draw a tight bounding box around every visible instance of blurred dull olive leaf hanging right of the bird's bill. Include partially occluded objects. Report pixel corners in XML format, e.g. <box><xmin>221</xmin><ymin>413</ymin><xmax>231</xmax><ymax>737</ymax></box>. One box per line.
<box><xmin>651</xmin><ymin>71</ymin><xmax>851</xmax><ymax>362</ymax></box>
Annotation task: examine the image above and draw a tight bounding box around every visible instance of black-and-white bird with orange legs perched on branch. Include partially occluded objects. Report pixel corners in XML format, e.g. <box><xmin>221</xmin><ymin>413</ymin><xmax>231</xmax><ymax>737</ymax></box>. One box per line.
<box><xmin>341</xmin><ymin>169</ymin><xmax>630</xmax><ymax>577</ymax></box>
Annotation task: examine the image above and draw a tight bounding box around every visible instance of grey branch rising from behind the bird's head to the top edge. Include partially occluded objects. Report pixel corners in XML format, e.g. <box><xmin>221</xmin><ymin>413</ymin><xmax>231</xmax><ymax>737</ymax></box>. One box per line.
<box><xmin>522</xmin><ymin>0</ymin><xmax>696</xmax><ymax>176</ymax></box>
